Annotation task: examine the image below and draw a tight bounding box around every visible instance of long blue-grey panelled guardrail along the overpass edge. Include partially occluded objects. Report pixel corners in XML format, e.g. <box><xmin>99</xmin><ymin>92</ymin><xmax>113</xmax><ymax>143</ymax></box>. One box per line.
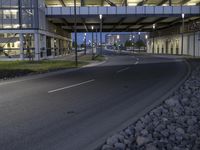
<box><xmin>46</xmin><ymin>6</ymin><xmax>200</xmax><ymax>16</ymax></box>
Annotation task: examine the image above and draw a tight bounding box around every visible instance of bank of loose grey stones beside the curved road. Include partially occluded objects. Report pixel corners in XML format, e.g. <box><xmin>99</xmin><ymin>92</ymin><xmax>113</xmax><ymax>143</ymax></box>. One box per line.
<box><xmin>101</xmin><ymin>67</ymin><xmax>200</xmax><ymax>150</ymax></box>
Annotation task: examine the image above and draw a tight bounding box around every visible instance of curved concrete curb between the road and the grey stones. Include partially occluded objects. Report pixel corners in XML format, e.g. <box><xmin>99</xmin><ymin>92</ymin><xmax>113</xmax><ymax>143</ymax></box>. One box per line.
<box><xmin>94</xmin><ymin>59</ymin><xmax>192</xmax><ymax>150</ymax></box>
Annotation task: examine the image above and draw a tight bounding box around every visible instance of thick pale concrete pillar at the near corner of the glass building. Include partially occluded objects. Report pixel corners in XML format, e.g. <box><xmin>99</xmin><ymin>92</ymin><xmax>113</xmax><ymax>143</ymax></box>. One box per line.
<box><xmin>34</xmin><ymin>33</ymin><xmax>40</xmax><ymax>61</ymax></box>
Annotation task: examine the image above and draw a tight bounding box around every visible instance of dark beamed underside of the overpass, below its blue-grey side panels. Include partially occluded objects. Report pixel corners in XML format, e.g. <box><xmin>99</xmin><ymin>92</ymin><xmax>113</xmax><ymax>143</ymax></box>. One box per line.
<box><xmin>49</xmin><ymin>15</ymin><xmax>200</xmax><ymax>32</ymax></box>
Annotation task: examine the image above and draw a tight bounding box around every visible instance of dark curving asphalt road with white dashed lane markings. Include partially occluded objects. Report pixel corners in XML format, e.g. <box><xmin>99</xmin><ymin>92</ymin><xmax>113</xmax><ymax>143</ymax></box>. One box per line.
<box><xmin>0</xmin><ymin>49</ymin><xmax>187</xmax><ymax>150</ymax></box>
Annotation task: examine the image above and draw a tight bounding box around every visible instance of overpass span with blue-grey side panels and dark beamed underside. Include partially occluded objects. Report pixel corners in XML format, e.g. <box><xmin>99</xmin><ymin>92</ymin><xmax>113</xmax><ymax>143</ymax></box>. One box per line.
<box><xmin>46</xmin><ymin>6</ymin><xmax>200</xmax><ymax>32</ymax></box>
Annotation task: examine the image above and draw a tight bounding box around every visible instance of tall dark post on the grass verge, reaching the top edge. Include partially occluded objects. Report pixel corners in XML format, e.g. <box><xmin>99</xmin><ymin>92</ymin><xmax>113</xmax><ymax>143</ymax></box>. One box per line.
<box><xmin>74</xmin><ymin>0</ymin><xmax>78</xmax><ymax>66</ymax></box>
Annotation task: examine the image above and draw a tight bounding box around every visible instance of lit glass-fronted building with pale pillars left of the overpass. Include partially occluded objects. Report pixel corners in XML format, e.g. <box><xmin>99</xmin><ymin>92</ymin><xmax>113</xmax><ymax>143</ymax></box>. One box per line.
<box><xmin>0</xmin><ymin>0</ymin><xmax>71</xmax><ymax>60</ymax></box>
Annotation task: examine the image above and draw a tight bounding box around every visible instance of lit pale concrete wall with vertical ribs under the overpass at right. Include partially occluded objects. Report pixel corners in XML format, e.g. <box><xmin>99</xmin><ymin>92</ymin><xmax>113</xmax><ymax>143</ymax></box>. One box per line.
<box><xmin>147</xmin><ymin>31</ymin><xmax>200</xmax><ymax>56</ymax></box>
